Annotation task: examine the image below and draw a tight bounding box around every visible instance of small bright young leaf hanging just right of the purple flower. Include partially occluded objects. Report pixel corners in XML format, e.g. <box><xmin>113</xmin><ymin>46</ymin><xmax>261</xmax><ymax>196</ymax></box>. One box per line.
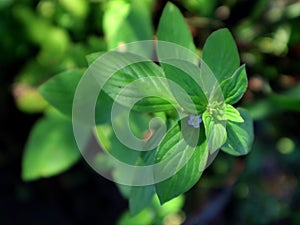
<box><xmin>202</xmin><ymin>111</ymin><xmax>227</xmax><ymax>154</ymax></box>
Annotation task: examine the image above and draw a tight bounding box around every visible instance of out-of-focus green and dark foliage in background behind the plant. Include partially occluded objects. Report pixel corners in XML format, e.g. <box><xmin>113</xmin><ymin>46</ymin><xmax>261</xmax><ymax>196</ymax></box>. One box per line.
<box><xmin>0</xmin><ymin>0</ymin><xmax>300</xmax><ymax>225</ymax></box>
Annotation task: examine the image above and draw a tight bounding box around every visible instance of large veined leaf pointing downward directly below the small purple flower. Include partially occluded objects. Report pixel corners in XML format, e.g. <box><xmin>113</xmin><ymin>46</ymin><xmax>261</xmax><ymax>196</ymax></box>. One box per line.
<box><xmin>154</xmin><ymin>121</ymin><xmax>208</xmax><ymax>204</ymax></box>
